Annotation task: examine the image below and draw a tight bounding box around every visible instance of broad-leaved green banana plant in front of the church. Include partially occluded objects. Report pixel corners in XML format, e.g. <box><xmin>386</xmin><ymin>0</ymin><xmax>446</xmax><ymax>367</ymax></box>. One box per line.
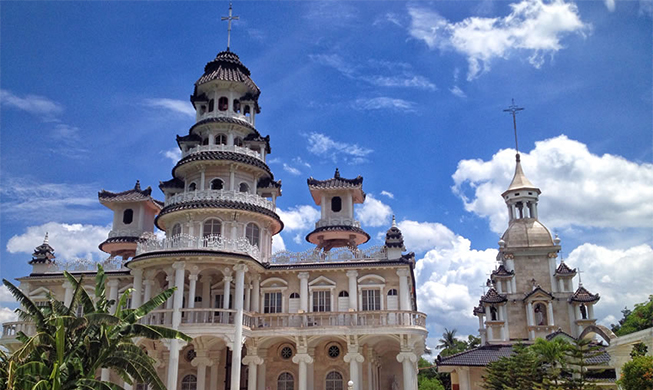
<box><xmin>0</xmin><ymin>266</ymin><xmax>191</xmax><ymax>390</ymax></box>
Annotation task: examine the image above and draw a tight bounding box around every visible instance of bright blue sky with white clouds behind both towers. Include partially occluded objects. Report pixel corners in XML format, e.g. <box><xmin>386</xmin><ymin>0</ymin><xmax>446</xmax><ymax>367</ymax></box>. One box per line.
<box><xmin>0</xmin><ymin>0</ymin><xmax>653</xmax><ymax>350</ymax></box>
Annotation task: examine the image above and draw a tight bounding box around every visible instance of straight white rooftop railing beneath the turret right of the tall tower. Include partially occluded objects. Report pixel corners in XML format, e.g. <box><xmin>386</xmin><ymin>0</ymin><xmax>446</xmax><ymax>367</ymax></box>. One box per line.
<box><xmin>270</xmin><ymin>245</ymin><xmax>388</xmax><ymax>264</ymax></box>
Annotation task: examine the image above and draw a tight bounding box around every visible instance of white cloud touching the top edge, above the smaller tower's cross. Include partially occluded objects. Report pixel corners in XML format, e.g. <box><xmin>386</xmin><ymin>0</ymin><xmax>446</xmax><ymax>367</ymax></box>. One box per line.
<box><xmin>408</xmin><ymin>0</ymin><xmax>590</xmax><ymax>80</ymax></box>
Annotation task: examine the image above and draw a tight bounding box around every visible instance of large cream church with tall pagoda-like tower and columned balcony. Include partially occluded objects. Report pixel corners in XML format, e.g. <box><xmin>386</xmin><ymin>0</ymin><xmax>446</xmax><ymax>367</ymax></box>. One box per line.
<box><xmin>0</xmin><ymin>35</ymin><xmax>427</xmax><ymax>390</ymax></box>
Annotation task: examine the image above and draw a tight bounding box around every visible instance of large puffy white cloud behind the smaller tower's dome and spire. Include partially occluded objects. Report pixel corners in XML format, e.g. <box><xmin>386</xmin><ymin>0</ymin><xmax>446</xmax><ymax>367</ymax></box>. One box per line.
<box><xmin>453</xmin><ymin>135</ymin><xmax>653</xmax><ymax>233</ymax></box>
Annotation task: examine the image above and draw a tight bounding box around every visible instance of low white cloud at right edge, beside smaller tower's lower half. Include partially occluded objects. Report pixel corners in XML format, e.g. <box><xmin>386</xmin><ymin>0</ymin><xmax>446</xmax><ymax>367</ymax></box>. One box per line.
<box><xmin>565</xmin><ymin>243</ymin><xmax>653</xmax><ymax>326</ymax></box>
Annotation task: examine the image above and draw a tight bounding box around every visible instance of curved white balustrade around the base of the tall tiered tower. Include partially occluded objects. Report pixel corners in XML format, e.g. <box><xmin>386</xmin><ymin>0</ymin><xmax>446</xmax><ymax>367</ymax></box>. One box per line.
<box><xmin>136</xmin><ymin>234</ymin><xmax>260</xmax><ymax>260</ymax></box>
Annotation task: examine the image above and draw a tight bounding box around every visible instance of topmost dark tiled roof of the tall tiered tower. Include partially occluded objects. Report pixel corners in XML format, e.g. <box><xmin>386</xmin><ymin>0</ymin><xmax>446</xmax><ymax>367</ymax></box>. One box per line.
<box><xmin>195</xmin><ymin>50</ymin><xmax>261</xmax><ymax>99</ymax></box>
